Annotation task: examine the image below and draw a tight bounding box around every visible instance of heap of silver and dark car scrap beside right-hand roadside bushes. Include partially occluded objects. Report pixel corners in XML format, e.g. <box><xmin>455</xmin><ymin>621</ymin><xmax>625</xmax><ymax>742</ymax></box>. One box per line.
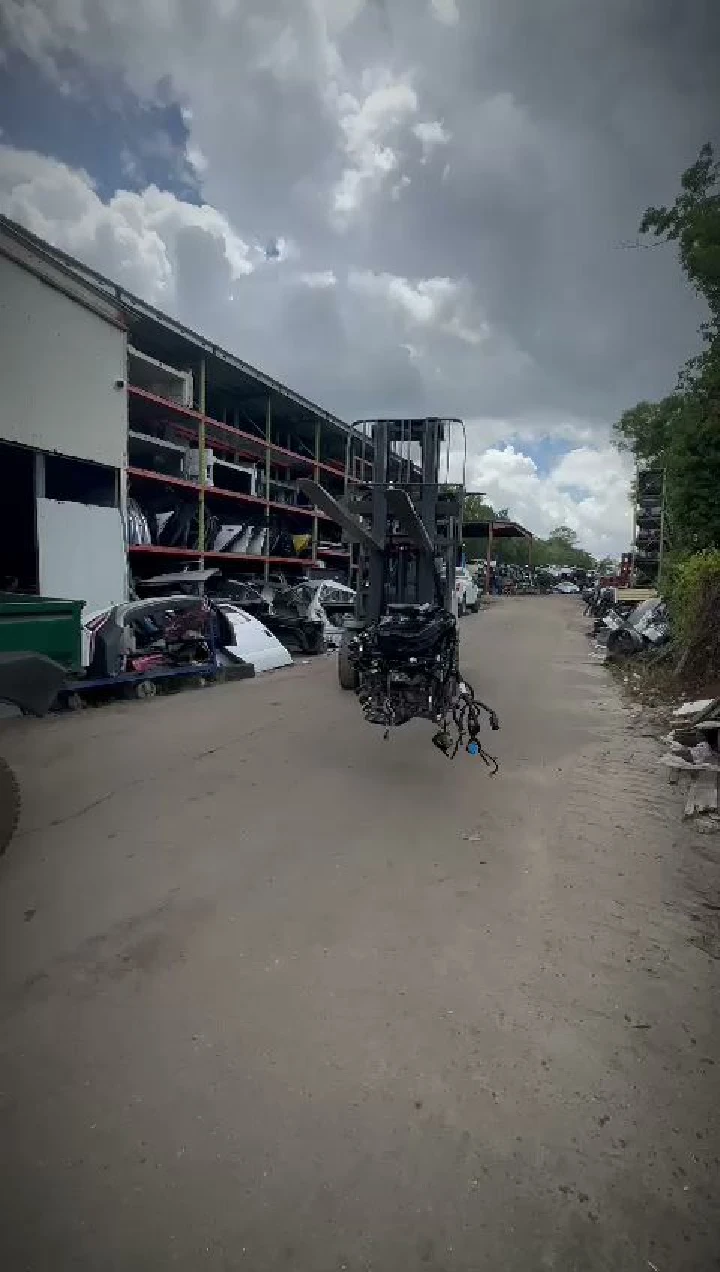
<box><xmin>583</xmin><ymin>588</ymin><xmax>670</xmax><ymax>658</ymax></box>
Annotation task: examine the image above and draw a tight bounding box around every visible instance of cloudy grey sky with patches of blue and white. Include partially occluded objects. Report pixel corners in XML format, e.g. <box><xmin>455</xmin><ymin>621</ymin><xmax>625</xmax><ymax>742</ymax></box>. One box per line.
<box><xmin>0</xmin><ymin>0</ymin><xmax>720</xmax><ymax>555</ymax></box>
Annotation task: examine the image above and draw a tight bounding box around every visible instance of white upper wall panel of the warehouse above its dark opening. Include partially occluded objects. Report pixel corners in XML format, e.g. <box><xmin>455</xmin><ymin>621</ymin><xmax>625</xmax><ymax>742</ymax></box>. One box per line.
<box><xmin>0</xmin><ymin>243</ymin><xmax>127</xmax><ymax>468</ymax></box>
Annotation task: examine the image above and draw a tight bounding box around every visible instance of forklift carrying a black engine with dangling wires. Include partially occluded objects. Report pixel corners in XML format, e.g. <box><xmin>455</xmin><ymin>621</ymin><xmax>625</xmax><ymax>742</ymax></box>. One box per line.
<box><xmin>298</xmin><ymin>417</ymin><xmax>500</xmax><ymax>772</ymax></box>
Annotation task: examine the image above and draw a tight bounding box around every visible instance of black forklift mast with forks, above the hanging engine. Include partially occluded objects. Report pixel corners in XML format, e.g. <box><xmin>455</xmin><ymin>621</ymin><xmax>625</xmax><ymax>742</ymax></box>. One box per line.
<box><xmin>299</xmin><ymin>417</ymin><xmax>463</xmax><ymax>626</ymax></box>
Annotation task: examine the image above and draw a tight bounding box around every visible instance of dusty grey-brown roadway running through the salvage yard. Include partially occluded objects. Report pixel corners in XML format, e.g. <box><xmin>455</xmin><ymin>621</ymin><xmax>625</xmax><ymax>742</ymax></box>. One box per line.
<box><xmin>0</xmin><ymin>598</ymin><xmax>720</xmax><ymax>1272</ymax></box>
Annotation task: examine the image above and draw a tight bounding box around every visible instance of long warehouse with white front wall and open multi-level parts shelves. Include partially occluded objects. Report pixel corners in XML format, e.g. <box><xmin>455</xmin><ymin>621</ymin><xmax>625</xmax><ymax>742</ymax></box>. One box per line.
<box><xmin>0</xmin><ymin>218</ymin><xmax>363</xmax><ymax>611</ymax></box>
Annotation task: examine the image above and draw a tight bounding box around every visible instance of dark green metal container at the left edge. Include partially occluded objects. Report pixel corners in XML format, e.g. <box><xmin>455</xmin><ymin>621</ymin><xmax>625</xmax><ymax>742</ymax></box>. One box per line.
<box><xmin>0</xmin><ymin>591</ymin><xmax>85</xmax><ymax>672</ymax></box>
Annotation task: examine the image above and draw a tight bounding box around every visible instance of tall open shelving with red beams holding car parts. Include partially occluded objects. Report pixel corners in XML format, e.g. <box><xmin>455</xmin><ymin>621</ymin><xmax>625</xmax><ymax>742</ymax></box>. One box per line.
<box><xmin>121</xmin><ymin>312</ymin><xmax>352</xmax><ymax>590</ymax></box>
